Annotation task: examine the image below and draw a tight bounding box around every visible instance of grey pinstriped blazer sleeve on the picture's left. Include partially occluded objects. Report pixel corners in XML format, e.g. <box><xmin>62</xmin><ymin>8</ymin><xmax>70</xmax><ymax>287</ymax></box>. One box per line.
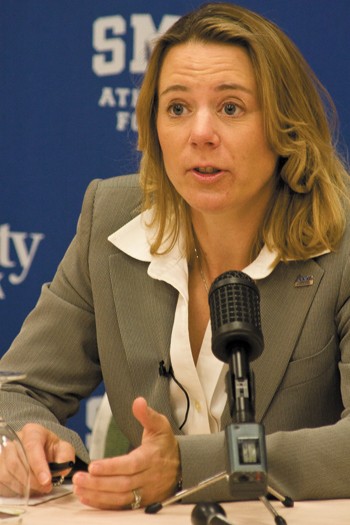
<box><xmin>0</xmin><ymin>179</ymin><xmax>105</xmax><ymax>462</ymax></box>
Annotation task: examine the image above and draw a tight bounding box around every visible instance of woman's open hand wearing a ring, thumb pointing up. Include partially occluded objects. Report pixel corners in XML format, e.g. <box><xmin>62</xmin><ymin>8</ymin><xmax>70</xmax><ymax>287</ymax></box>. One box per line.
<box><xmin>73</xmin><ymin>397</ymin><xmax>180</xmax><ymax>509</ymax></box>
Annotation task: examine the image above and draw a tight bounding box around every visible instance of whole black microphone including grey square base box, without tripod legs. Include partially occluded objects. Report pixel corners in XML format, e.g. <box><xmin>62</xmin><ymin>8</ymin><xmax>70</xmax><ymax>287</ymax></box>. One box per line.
<box><xmin>209</xmin><ymin>271</ymin><xmax>267</xmax><ymax>499</ymax></box>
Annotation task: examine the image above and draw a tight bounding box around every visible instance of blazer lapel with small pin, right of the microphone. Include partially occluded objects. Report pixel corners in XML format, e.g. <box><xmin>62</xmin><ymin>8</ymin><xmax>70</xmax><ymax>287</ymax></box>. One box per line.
<box><xmin>252</xmin><ymin>259</ymin><xmax>324</xmax><ymax>421</ymax></box>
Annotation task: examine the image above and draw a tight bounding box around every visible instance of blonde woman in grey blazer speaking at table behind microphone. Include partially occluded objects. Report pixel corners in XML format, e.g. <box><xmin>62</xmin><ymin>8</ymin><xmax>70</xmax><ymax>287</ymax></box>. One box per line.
<box><xmin>1</xmin><ymin>4</ymin><xmax>350</xmax><ymax>508</ymax></box>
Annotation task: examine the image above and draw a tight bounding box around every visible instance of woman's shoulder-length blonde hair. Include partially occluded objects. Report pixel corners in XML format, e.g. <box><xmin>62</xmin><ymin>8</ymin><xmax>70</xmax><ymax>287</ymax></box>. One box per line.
<box><xmin>136</xmin><ymin>3</ymin><xmax>348</xmax><ymax>260</ymax></box>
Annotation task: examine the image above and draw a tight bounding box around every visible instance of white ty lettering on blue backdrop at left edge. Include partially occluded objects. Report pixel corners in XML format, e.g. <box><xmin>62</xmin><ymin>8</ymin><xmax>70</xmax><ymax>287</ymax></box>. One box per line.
<box><xmin>0</xmin><ymin>224</ymin><xmax>45</xmax><ymax>299</ymax></box>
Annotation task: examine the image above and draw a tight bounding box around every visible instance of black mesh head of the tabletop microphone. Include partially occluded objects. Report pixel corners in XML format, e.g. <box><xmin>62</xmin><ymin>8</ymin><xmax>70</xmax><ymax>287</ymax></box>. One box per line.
<box><xmin>209</xmin><ymin>271</ymin><xmax>263</xmax><ymax>362</ymax></box>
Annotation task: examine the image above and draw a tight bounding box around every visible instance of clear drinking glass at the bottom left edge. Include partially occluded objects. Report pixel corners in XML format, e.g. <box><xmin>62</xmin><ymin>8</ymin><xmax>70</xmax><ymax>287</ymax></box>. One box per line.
<box><xmin>0</xmin><ymin>371</ymin><xmax>30</xmax><ymax>525</ymax></box>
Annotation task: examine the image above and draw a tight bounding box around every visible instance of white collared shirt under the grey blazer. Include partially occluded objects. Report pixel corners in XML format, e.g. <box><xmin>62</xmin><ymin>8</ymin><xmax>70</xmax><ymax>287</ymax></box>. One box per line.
<box><xmin>108</xmin><ymin>211</ymin><xmax>328</xmax><ymax>434</ymax></box>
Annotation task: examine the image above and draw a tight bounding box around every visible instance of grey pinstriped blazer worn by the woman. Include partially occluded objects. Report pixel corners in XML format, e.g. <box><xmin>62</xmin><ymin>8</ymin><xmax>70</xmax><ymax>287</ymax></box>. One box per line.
<box><xmin>0</xmin><ymin>175</ymin><xmax>350</xmax><ymax>501</ymax></box>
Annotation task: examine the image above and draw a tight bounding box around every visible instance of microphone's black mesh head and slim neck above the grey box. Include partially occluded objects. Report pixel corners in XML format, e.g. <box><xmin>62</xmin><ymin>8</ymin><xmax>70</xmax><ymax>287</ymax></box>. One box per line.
<box><xmin>209</xmin><ymin>271</ymin><xmax>264</xmax><ymax>423</ymax></box>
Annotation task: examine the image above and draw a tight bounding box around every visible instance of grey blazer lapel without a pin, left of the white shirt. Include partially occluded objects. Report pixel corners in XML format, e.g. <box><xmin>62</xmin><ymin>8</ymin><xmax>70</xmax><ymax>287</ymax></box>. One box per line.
<box><xmin>109</xmin><ymin>252</ymin><xmax>178</xmax><ymax>431</ymax></box>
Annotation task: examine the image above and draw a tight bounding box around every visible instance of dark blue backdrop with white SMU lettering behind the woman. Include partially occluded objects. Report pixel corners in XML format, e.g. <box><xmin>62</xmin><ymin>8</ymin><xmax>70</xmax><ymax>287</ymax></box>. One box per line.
<box><xmin>0</xmin><ymin>0</ymin><xmax>350</xmax><ymax>446</ymax></box>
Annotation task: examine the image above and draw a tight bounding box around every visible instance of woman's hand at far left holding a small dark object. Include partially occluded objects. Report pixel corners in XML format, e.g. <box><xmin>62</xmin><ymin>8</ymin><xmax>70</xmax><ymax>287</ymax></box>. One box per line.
<box><xmin>18</xmin><ymin>423</ymin><xmax>75</xmax><ymax>494</ymax></box>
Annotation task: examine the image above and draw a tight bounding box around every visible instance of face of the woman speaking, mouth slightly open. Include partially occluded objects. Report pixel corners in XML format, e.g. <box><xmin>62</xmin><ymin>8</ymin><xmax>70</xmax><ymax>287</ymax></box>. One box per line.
<box><xmin>157</xmin><ymin>42</ymin><xmax>277</xmax><ymax>219</ymax></box>
